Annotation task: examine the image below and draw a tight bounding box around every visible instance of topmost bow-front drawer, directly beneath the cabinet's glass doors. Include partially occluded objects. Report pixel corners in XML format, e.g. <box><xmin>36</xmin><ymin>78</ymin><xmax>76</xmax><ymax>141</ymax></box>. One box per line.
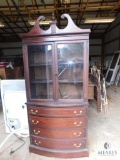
<box><xmin>28</xmin><ymin>106</ymin><xmax>86</xmax><ymax>117</ymax></box>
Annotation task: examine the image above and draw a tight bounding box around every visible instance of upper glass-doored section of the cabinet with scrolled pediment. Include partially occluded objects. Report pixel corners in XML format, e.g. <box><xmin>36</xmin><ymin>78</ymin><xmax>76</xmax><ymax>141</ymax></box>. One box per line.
<box><xmin>21</xmin><ymin>14</ymin><xmax>90</xmax><ymax>101</ymax></box>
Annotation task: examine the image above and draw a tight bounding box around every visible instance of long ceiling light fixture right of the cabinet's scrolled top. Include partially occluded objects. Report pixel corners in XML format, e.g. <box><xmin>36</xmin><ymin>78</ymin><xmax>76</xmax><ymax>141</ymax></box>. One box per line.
<box><xmin>84</xmin><ymin>17</ymin><xmax>115</xmax><ymax>23</ymax></box>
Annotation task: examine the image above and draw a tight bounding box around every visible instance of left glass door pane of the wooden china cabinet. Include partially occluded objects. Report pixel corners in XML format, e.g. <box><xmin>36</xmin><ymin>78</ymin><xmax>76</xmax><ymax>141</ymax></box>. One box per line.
<box><xmin>28</xmin><ymin>45</ymin><xmax>53</xmax><ymax>99</ymax></box>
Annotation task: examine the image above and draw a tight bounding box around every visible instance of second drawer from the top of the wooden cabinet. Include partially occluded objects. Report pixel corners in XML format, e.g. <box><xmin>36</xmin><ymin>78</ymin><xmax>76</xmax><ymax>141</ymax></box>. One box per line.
<box><xmin>29</xmin><ymin>115</ymin><xmax>87</xmax><ymax>128</ymax></box>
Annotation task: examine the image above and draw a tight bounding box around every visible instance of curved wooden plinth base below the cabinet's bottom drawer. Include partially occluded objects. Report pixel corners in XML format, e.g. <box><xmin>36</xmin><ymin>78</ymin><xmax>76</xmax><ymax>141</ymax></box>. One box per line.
<box><xmin>29</xmin><ymin>145</ymin><xmax>89</xmax><ymax>158</ymax></box>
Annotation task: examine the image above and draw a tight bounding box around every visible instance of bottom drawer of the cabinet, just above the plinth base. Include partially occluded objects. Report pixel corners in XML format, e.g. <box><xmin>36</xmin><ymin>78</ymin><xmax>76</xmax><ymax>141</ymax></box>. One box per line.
<box><xmin>31</xmin><ymin>136</ymin><xmax>86</xmax><ymax>150</ymax></box>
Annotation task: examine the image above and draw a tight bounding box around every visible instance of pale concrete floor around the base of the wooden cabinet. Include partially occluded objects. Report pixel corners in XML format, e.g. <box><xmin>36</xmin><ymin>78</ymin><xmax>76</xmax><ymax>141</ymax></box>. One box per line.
<box><xmin>0</xmin><ymin>87</ymin><xmax>120</xmax><ymax>160</ymax></box>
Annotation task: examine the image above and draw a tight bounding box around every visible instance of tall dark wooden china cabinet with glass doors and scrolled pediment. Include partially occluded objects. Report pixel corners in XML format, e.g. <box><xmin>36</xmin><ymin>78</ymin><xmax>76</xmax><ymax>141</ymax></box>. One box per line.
<box><xmin>20</xmin><ymin>14</ymin><xmax>90</xmax><ymax>158</ymax></box>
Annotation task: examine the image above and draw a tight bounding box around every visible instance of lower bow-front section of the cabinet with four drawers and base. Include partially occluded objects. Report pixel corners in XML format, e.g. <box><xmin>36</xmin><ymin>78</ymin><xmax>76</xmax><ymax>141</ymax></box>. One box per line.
<box><xmin>28</xmin><ymin>104</ymin><xmax>88</xmax><ymax>158</ymax></box>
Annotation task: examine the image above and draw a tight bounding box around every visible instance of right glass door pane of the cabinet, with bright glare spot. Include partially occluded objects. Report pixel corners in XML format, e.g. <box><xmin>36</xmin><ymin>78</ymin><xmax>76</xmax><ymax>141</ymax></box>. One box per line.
<box><xmin>57</xmin><ymin>43</ymin><xmax>83</xmax><ymax>99</ymax></box>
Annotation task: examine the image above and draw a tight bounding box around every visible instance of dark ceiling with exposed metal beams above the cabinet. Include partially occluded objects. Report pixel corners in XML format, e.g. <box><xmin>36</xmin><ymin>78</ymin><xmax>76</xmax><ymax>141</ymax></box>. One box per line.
<box><xmin>0</xmin><ymin>0</ymin><xmax>120</xmax><ymax>42</ymax></box>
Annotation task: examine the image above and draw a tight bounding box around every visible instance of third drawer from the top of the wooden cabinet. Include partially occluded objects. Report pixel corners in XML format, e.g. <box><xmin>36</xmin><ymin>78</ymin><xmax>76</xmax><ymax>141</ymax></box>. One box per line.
<box><xmin>30</xmin><ymin>127</ymin><xmax>86</xmax><ymax>139</ymax></box>
